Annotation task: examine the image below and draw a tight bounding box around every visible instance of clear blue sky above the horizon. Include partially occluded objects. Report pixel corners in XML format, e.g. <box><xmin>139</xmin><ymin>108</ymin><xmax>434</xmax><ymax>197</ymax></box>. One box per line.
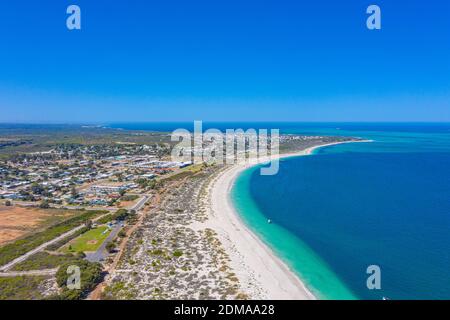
<box><xmin>0</xmin><ymin>0</ymin><xmax>450</xmax><ymax>123</ymax></box>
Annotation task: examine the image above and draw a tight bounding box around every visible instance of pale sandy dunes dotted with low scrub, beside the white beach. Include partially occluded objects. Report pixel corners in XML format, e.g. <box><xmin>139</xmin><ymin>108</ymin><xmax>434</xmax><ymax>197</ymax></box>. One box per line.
<box><xmin>102</xmin><ymin>170</ymin><xmax>246</xmax><ymax>299</ymax></box>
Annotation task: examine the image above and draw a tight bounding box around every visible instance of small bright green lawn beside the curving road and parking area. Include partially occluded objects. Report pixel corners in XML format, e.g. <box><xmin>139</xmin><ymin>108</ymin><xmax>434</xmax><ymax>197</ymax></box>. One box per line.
<box><xmin>62</xmin><ymin>226</ymin><xmax>111</xmax><ymax>253</ymax></box>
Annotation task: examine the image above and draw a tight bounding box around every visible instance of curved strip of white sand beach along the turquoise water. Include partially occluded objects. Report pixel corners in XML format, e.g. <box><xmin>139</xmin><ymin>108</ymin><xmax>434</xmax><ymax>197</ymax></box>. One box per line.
<box><xmin>208</xmin><ymin>140</ymin><xmax>369</xmax><ymax>300</ymax></box>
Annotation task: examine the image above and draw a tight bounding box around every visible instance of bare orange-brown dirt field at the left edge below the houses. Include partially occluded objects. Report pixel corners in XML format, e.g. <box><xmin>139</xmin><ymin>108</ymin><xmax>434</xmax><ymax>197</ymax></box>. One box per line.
<box><xmin>0</xmin><ymin>206</ymin><xmax>78</xmax><ymax>246</ymax></box>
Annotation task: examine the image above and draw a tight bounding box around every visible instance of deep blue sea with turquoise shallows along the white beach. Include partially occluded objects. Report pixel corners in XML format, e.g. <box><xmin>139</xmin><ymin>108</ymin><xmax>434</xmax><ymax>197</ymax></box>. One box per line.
<box><xmin>110</xmin><ymin>123</ymin><xmax>450</xmax><ymax>299</ymax></box>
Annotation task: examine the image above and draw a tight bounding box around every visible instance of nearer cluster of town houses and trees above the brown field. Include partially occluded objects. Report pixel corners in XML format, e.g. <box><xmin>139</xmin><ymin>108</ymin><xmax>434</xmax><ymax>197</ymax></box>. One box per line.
<box><xmin>0</xmin><ymin>145</ymin><xmax>190</xmax><ymax>207</ymax></box>
